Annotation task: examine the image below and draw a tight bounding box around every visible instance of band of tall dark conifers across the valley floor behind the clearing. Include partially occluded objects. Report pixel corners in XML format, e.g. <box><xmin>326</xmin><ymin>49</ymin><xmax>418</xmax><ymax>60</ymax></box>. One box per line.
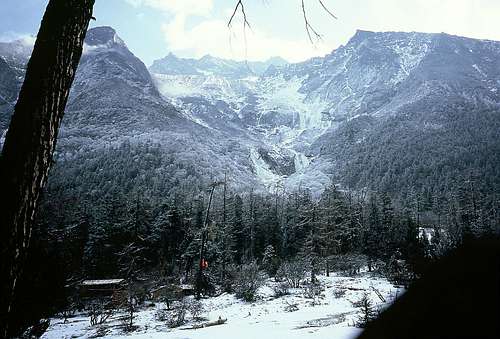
<box><xmin>14</xmin><ymin>175</ymin><xmax>500</xmax><ymax>318</ymax></box>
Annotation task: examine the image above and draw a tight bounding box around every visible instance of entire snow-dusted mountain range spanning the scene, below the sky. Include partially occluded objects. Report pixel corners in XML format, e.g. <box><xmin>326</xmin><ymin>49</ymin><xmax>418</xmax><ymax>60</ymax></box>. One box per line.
<box><xmin>0</xmin><ymin>27</ymin><xmax>500</xmax><ymax>191</ymax></box>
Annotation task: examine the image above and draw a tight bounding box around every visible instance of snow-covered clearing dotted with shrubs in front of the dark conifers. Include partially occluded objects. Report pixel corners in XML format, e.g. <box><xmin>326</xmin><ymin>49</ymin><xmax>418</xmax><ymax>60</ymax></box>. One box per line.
<box><xmin>42</xmin><ymin>273</ymin><xmax>403</xmax><ymax>339</ymax></box>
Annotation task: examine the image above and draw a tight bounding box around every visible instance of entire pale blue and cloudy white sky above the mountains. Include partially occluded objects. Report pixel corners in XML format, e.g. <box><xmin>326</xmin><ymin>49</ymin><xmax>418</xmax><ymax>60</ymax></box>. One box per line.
<box><xmin>0</xmin><ymin>0</ymin><xmax>500</xmax><ymax>65</ymax></box>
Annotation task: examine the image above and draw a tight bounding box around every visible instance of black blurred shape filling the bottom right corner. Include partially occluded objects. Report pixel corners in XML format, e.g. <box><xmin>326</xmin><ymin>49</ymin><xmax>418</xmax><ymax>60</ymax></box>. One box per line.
<box><xmin>358</xmin><ymin>238</ymin><xmax>500</xmax><ymax>339</ymax></box>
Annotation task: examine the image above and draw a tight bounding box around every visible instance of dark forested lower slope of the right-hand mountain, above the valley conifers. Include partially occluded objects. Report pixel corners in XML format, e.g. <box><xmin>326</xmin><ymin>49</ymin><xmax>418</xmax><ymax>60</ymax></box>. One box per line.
<box><xmin>315</xmin><ymin>106</ymin><xmax>500</xmax><ymax>200</ymax></box>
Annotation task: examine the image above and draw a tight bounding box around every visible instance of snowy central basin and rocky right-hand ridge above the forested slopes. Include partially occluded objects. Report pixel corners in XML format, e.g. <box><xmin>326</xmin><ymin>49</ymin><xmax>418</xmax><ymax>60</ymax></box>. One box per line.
<box><xmin>150</xmin><ymin>31</ymin><xmax>500</xmax><ymax>193</ymax></box>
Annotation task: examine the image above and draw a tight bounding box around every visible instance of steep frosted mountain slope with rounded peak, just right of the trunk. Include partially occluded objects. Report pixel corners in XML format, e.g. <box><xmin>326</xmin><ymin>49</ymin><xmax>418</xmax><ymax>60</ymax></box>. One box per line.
<box><xmin>1</xmin><ymin>27</ymin><xmax>274</xmax><ymax>195</ymax></box>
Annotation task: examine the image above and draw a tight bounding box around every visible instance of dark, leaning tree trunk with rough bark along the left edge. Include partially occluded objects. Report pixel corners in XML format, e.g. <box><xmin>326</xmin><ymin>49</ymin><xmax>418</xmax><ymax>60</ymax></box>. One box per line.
<box><xmin>0</xmin><ymin>0</ymin><xmax>95</xmax><ymax>337</ymax></box>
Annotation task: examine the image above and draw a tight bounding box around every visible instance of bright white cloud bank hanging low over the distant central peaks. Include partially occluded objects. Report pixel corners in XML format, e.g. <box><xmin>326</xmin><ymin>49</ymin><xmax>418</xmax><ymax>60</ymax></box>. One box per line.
<box><xmin>125</xmin><ymin>0</ymin><xmax>329</xmax><ymax>61</ymax></box>
